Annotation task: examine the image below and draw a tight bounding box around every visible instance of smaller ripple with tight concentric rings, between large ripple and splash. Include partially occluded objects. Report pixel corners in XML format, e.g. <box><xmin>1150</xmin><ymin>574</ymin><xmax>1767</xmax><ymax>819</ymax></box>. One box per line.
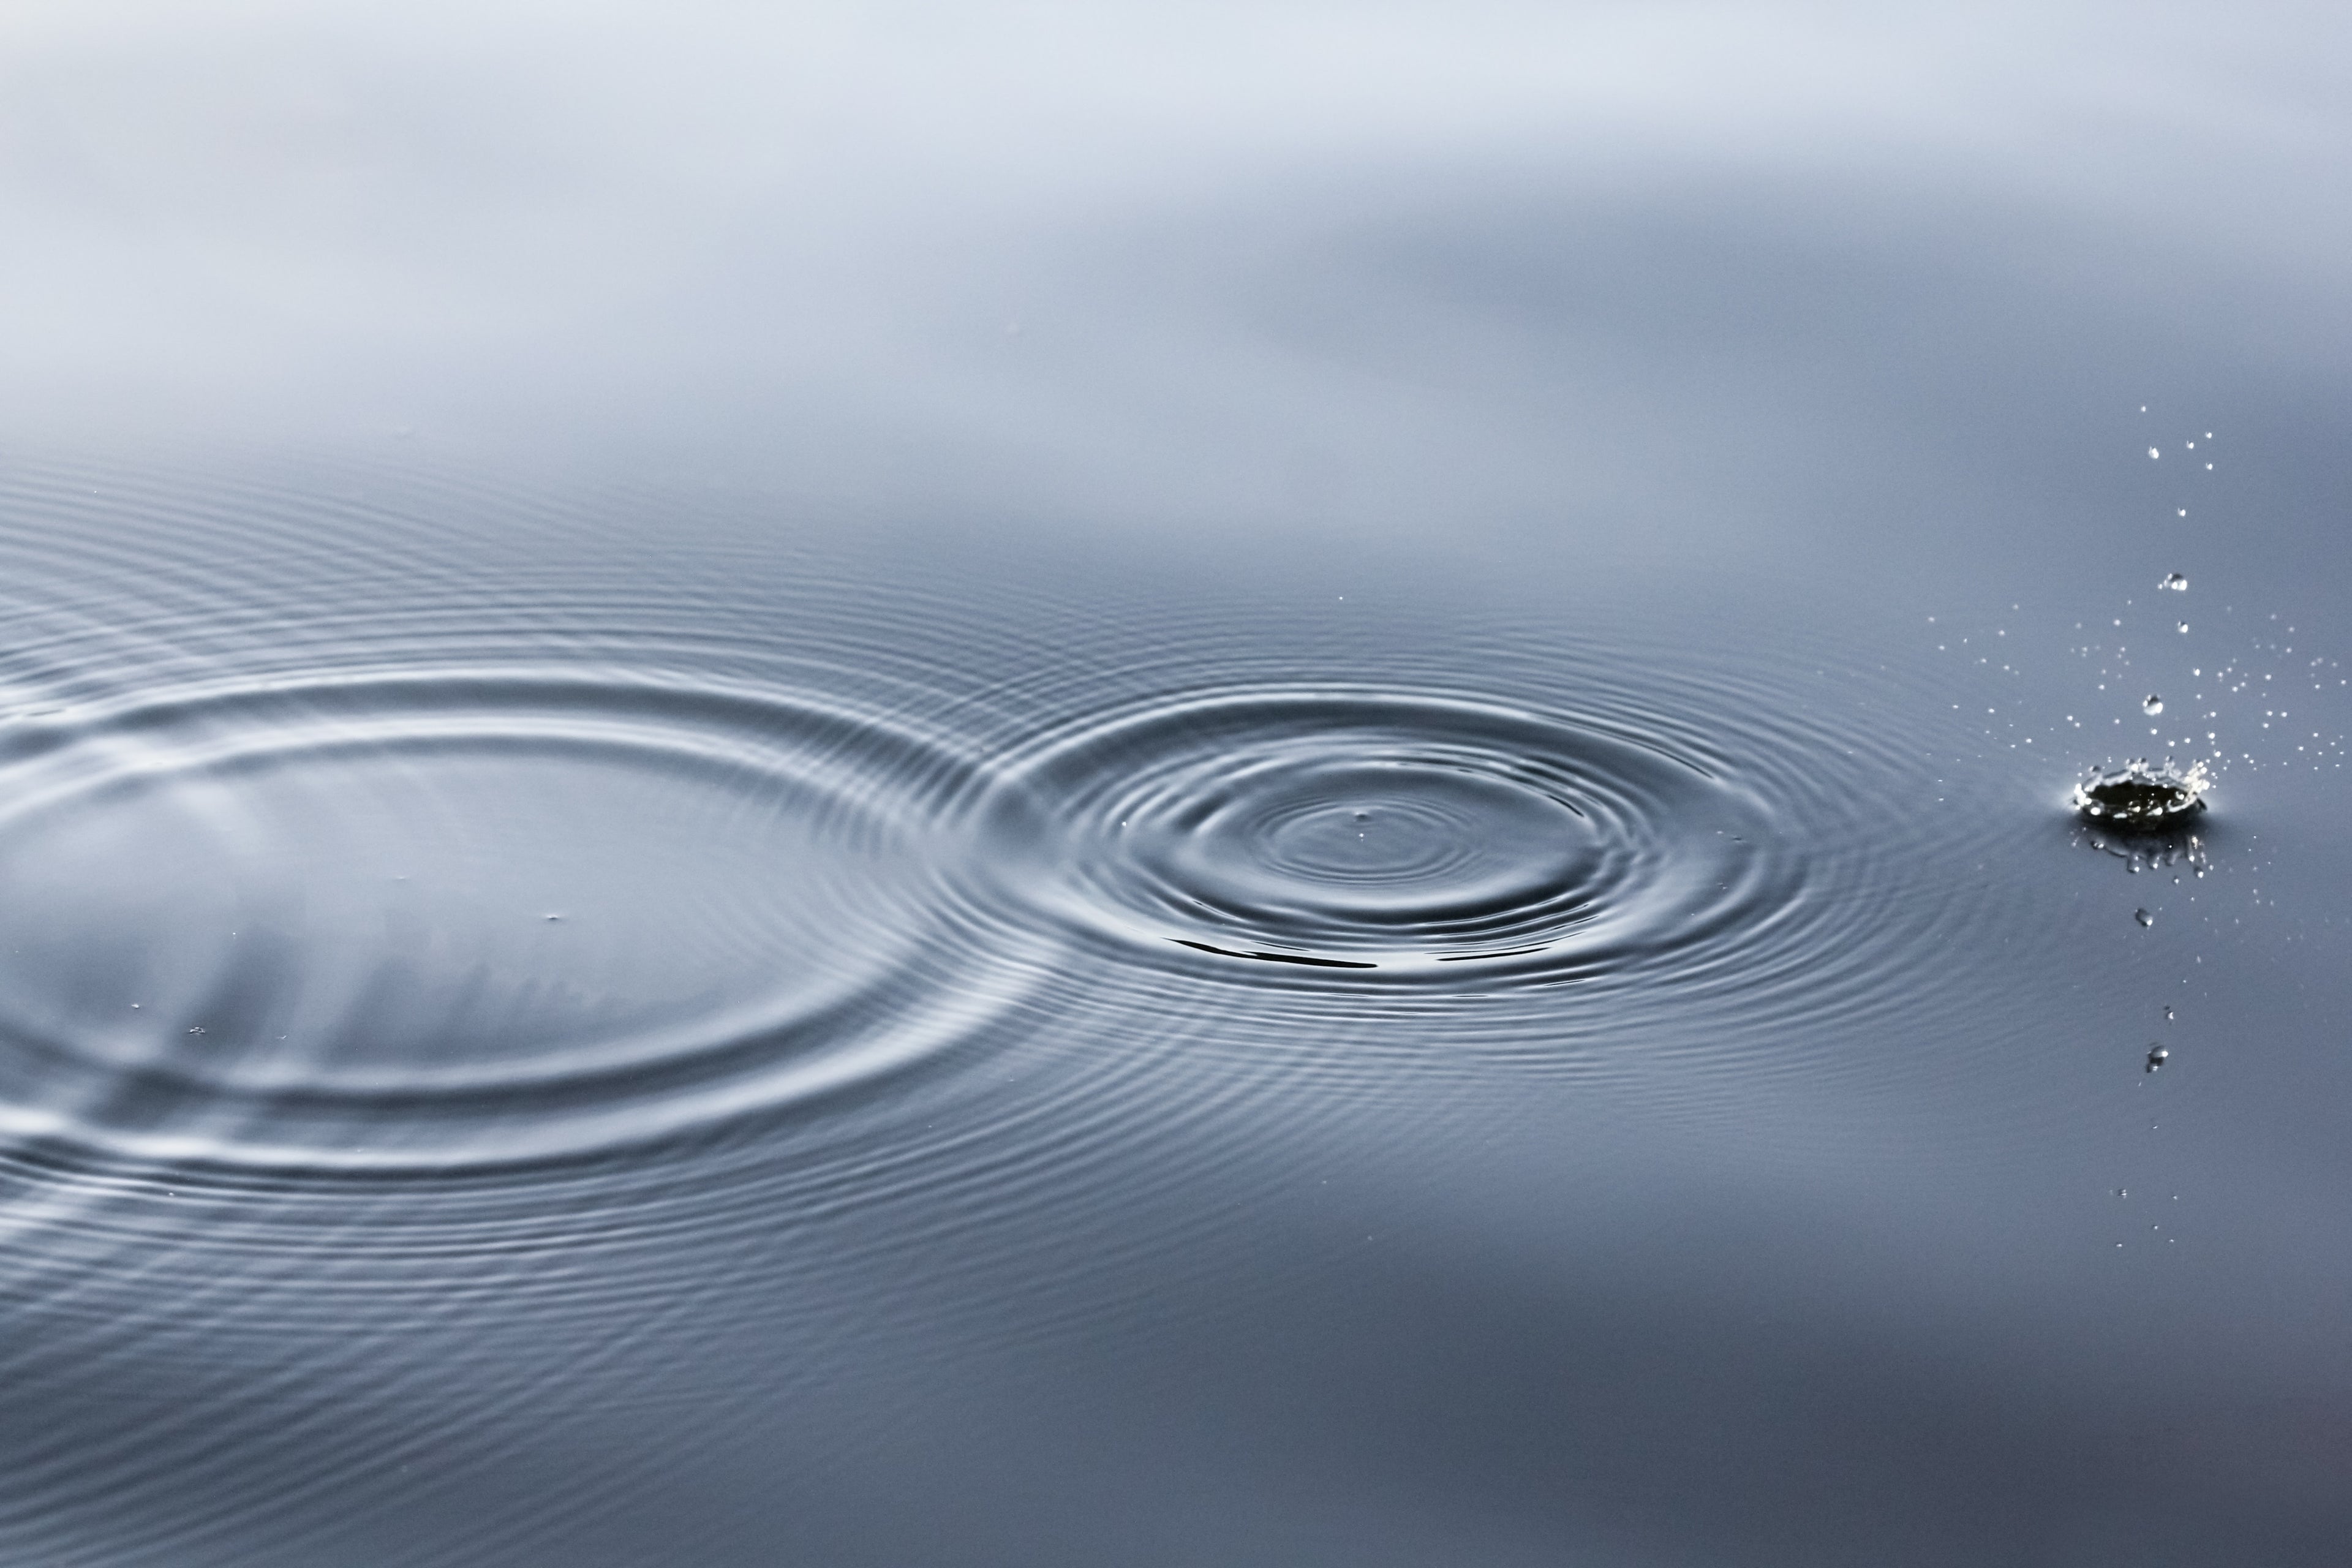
<box><xmin>986</xmin><ymin>689</ymin><xmax>1801</xmax><ymax>985</ymax></box>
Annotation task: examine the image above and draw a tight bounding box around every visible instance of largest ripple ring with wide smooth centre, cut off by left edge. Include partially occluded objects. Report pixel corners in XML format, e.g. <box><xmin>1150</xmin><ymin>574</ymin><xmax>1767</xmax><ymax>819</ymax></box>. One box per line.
<box><xmin>0</xmin><ymin>673</ymin><xmax>1021</xmax><ymax>1173</ymax></box>
